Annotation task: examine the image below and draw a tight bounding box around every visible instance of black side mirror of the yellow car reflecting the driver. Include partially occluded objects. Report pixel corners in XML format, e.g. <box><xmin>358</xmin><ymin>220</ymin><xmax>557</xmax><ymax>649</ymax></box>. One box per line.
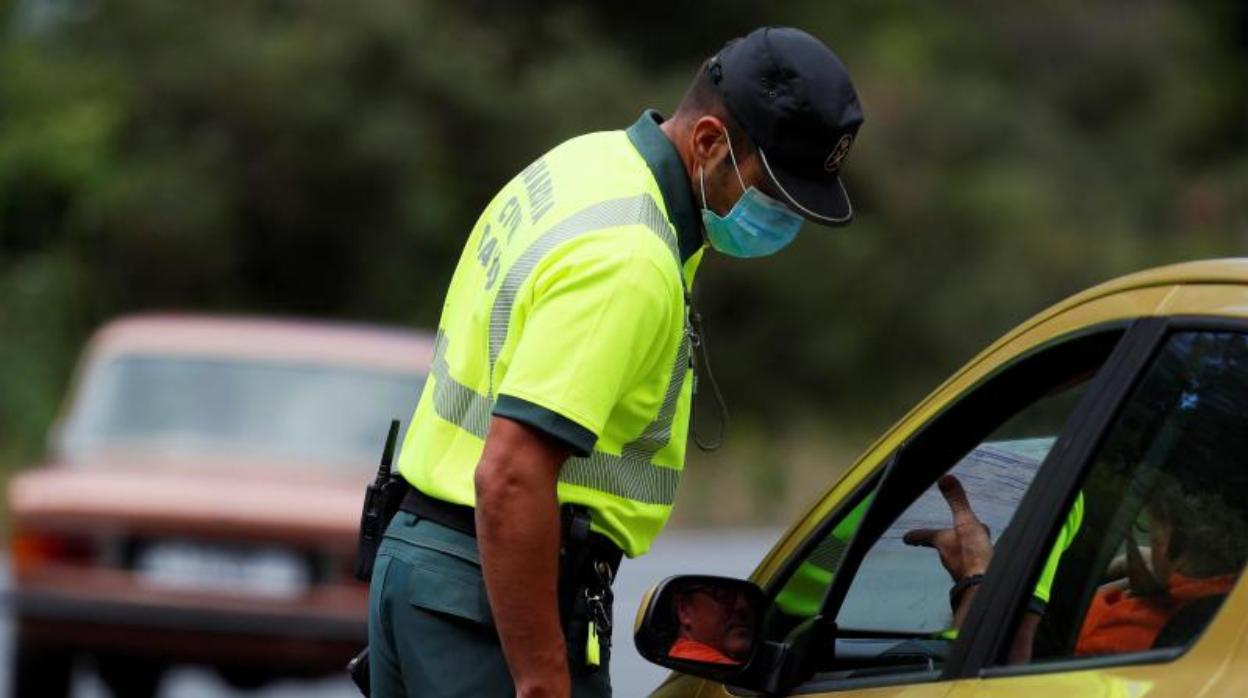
<box><xmin>633</xmin><ymin>574</ymin><xmax>765</xmax><ymax>682</ymax></box>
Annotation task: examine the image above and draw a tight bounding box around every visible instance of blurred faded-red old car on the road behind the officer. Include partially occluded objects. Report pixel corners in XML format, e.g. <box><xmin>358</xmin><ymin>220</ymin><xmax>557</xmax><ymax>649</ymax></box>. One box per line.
<box><xmin>9</xmin><ymin>316</ymin><xmax>433</xmax><ymax>698</ymax></box>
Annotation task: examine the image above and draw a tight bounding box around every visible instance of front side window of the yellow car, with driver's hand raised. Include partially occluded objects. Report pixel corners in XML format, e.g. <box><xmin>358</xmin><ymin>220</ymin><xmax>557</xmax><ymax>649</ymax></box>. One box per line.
<box><xmin>765</xmin><ymin>331</ymin><xmax>1121</xmax><ymax>678</ymax></box>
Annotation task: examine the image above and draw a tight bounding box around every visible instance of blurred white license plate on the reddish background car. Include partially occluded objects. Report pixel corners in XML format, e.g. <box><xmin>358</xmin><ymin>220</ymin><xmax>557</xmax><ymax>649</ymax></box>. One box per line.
<box><xmin>135</xmin><ymin>542</ymin><xmax>311</xmax><ymax>598</ymax></box>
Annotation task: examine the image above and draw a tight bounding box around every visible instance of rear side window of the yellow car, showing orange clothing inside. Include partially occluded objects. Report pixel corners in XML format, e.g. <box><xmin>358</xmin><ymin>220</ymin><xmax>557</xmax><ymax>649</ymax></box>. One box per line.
<box><xmin>1003</xmin><ymin>332</ymin><xmax>1248</xmax><ymax>663</ymax></box>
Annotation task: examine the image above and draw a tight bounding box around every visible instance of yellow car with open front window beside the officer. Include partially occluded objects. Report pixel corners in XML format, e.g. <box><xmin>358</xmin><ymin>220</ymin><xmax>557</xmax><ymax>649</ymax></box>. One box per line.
<box><xmin>634</xmin><ymin>260</ymin><xmax>1248</xmax><ymax>698</ymax></box>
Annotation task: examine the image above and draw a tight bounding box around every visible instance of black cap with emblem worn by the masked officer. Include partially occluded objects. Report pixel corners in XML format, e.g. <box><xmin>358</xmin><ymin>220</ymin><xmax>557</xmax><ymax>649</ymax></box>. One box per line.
<box><xmin>706</xmin><ymin>26</ymin><xmax>862</xmax><ymax>225</ymax></box>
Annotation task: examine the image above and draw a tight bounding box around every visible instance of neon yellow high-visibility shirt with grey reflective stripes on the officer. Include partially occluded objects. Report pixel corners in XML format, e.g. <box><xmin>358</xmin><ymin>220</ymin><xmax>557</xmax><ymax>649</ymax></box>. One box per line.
<box><xmin>398</xmin><ymin>111</ymin><xmax>703</xmax><ymax>557</ymax></box>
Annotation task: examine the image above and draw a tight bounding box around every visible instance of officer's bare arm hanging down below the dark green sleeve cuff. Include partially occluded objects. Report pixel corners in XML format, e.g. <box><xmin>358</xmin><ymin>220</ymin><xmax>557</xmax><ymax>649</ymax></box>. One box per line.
<box><xmin>475</xmin><ymin>417</ymin><xmax>572</xmax><ymax>698</ymax></box>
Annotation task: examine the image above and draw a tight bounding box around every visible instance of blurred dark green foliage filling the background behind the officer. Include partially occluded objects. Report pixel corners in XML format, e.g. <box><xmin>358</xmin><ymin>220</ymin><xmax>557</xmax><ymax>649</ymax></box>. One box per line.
<box><xmin>0</xmin><ymin>0</ymin><xmax>1248</xmax><ymax>514</ymax></box>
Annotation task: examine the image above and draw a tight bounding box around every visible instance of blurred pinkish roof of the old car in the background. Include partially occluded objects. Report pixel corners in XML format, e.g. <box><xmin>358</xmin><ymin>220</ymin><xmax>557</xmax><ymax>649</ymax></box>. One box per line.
<box><xmin>89</xmin><ymin>313</ymin><xmax>433</xmax><ymax>372</ymax></box>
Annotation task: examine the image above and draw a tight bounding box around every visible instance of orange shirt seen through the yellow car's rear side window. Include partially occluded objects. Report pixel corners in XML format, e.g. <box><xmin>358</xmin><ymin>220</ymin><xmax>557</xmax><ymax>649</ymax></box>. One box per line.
<box><xmin>1075</xmin><ymin>574</ymin><xmax>1238</xmax><ymax>654</ymax></box>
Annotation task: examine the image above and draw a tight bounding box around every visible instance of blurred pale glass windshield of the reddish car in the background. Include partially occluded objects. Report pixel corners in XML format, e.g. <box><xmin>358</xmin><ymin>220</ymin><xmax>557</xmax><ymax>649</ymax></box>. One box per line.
<box><xmin>62</xmin><ymin>356</ymin><xmax>424</xmax><ymax>466</ymax></box>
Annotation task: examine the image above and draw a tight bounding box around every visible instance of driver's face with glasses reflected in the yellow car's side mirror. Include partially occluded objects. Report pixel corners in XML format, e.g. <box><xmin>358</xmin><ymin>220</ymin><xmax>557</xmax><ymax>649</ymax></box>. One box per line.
<box><xmin>675</xmin><ymin>586</ymin><xmax>754</xmax><ymax>661</ymax></box>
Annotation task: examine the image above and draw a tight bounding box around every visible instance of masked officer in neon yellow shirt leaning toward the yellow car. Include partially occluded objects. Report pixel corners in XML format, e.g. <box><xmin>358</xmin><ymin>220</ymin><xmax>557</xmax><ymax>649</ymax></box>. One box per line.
<box><xmin>369</xmin><ymin>27</ymin><xmax>862</xmax><ymax>698</ymax></box>
